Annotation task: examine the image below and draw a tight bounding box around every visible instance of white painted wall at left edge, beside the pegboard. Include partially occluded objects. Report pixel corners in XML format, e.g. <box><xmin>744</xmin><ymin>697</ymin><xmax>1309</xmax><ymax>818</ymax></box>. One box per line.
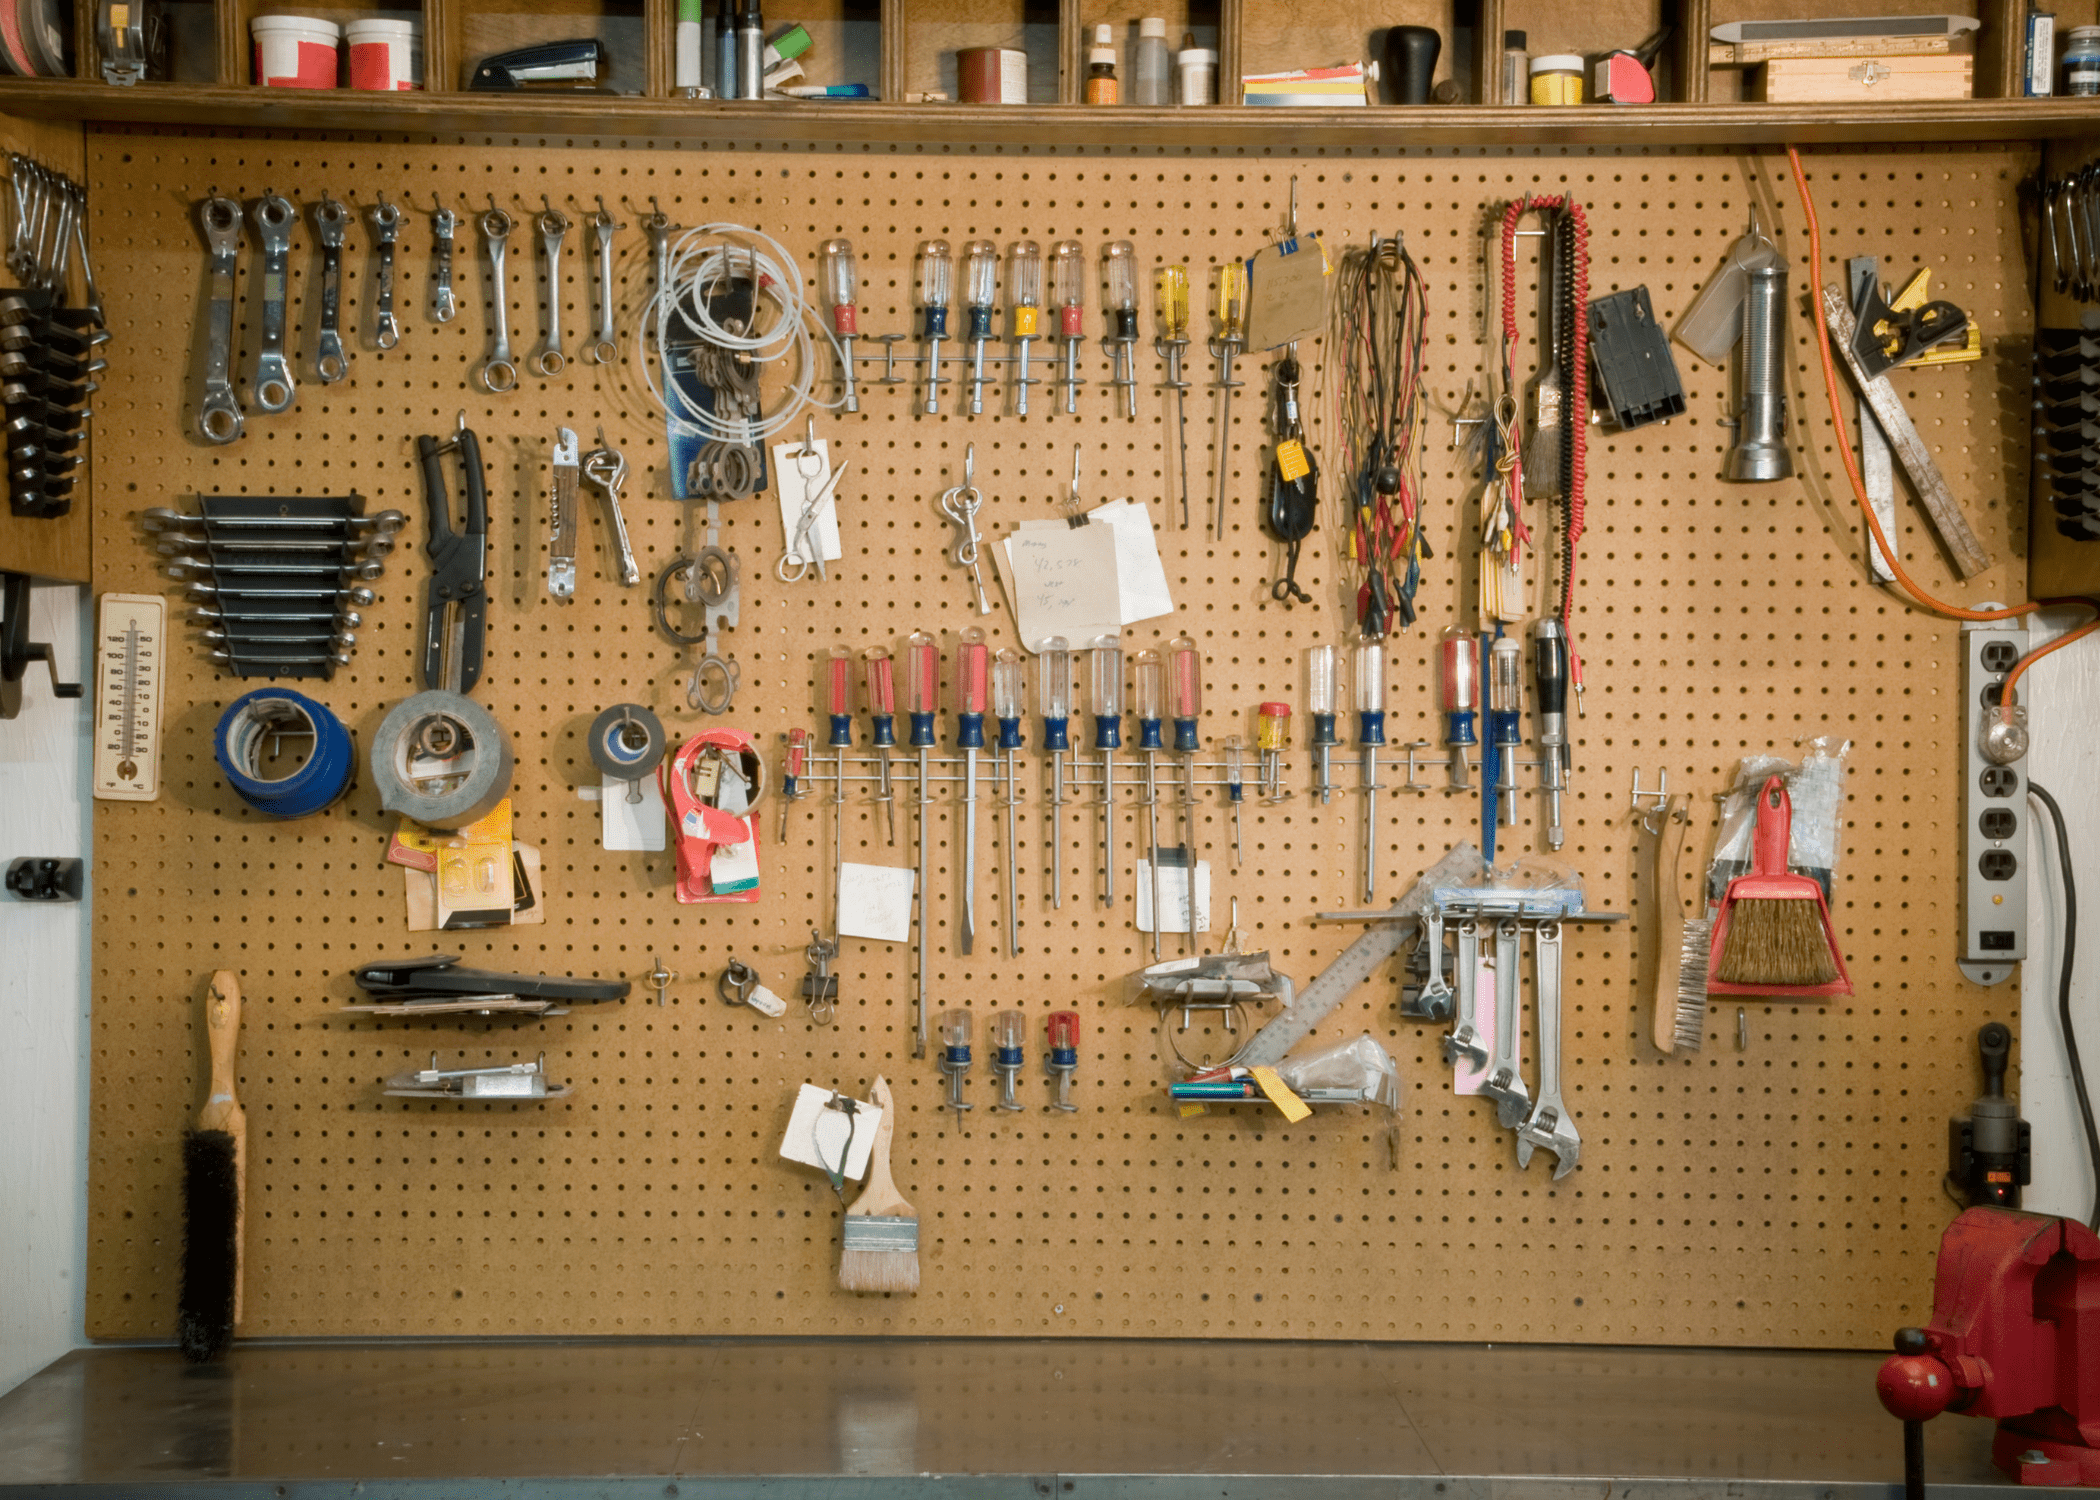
<box><xmin>0</xmin><ymin>584</ymin><xmax>92</xmax><ymax>1391</ymax></box>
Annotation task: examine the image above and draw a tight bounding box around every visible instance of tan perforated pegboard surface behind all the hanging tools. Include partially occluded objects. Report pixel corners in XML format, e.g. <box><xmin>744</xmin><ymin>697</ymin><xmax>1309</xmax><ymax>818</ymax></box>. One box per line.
<box><xmin>88</xmin><ymin>130</ymin><xmax>2035</xmax><ymax>1349</ymax></box>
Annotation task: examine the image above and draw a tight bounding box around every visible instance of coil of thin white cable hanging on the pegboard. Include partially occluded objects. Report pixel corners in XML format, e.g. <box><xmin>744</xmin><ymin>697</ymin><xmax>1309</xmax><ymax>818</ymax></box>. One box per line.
<box><xmin>634</xmin><ymin>223</ymin><xmax>844</xmax><ymax>445</ymax></box>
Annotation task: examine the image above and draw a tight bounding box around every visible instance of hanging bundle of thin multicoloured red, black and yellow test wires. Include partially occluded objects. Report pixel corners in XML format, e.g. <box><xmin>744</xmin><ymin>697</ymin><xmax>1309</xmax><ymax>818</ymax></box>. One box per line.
<box><xmin>1336</xmin><ymin>235</ymin><xmax>1430</xmax><ymax>641</ymax></box>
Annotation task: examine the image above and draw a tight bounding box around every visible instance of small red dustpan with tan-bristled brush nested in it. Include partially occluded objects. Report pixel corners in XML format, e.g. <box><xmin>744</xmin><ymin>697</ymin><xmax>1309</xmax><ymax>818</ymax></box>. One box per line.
<box><xmin>1707</xmin><ymin>775</ymin><xmax>1852</xmax><ymax>1000</ymax></box>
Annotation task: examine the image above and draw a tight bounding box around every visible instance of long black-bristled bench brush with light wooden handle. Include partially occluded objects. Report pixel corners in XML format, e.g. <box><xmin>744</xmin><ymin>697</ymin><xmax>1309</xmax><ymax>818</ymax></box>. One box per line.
<box><xmin>176</xmin><ymin>968</ymin><xmax>248</xmax><ymax>1361</ymax></box>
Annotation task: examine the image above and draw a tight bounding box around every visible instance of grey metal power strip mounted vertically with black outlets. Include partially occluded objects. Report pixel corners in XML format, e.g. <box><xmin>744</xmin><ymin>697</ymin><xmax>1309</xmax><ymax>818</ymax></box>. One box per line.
<box><xmin>1957</xmin><ymin>620</ymin><xmax>2027</xmax><ymax>985</ymax></box>
